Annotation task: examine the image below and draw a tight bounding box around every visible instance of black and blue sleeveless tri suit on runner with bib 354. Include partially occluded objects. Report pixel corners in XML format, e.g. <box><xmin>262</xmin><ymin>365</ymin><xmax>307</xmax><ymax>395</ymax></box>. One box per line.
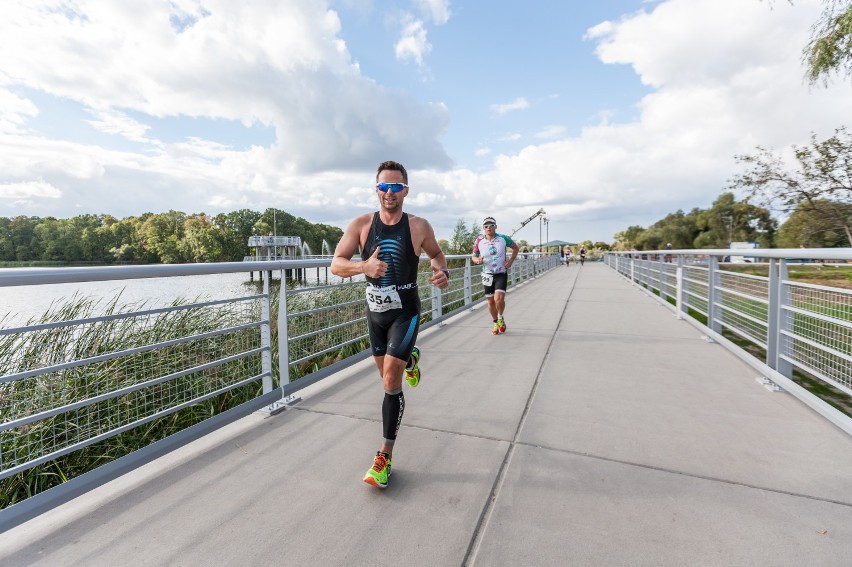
<box><xmin>361</xmin><ymin>211</ymin><xmax>420</xmax><ymax>361</ymax></box>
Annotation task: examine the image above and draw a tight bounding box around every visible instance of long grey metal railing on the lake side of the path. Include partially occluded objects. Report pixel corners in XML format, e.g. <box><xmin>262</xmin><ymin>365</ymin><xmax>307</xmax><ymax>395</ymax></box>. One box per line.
<box><xmin>0</xmin><ymin>254</ymin><xmax>559</xmax><ymax>506</ymax></box>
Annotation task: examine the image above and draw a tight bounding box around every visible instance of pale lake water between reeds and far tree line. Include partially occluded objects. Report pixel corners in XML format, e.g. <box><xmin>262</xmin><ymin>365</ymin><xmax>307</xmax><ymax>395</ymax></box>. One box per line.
<box><xmin>0</xmin><ymin>269</ymin><xmax>340</xmax><ymax>329</ymax></box>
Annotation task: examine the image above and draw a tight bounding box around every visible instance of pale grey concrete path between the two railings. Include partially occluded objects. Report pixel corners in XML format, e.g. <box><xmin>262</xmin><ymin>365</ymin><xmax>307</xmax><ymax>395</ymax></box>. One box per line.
<box><xmin>0</xmin><ymin>263</ymin><xmax>852</xmax><ymax>567</ymax></box>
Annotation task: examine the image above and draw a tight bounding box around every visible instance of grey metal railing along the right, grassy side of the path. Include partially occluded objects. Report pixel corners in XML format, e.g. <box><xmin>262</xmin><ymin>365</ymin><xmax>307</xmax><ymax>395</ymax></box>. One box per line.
<box><xmin>604</xmin><ymin>248</ymin><xmax>852</xmax><ymax>434</ymax></box>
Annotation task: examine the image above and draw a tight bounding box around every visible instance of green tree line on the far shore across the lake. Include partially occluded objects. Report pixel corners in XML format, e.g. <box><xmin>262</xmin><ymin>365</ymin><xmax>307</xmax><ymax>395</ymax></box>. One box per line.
<box><xmin>0</xmin><ymin>208</ymin><xmax>343</xmax><ymax>264</ymax></box>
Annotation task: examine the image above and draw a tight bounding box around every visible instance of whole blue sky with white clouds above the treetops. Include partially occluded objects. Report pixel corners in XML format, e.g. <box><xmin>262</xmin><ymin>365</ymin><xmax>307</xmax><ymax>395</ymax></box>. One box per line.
<box><xmin>0</xmin><ymin>0</ymin><xmax>852</xmax><ymax>243</ymax></box>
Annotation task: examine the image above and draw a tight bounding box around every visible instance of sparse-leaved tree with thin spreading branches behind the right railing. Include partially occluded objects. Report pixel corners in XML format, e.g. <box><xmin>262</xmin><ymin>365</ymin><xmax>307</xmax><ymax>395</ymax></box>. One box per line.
<box><xmin>731</xmin><ymin>127</ymin><xmax>852</xmax><ymax>246</ymax></box>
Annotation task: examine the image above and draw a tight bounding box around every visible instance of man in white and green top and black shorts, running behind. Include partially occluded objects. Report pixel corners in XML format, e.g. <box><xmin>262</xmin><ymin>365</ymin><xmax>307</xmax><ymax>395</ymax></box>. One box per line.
<box><xmin>472</xmin><ymin>217</ymin><xmax>518</xmax><ymax>335</ymax></box>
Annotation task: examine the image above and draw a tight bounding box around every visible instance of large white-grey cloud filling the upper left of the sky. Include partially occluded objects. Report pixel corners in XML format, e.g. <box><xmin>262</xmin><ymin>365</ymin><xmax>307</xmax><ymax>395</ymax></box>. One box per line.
<box><xmin>0</xmin><ymin>0</ymin><xmax>450</xmax><ymax>180</ymax></box>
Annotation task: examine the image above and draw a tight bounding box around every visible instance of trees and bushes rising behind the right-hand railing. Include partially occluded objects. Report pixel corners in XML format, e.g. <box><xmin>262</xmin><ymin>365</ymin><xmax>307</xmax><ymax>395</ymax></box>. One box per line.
<box><xmin>614</xmin><ymin>127</ymin><xmax>852</xmax><ymax>250</ymax></box>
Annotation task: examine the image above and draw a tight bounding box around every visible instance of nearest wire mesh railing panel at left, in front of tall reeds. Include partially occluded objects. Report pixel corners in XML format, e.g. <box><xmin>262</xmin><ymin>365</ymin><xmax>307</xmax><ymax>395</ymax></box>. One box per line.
<box><xmin>0</xmin><ymin>300</ymin><xmax>262</xmax><ymax>475</ymax></box>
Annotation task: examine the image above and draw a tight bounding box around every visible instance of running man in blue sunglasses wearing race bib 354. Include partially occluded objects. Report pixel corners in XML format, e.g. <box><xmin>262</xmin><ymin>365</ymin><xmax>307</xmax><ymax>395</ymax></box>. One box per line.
<box><xmin>331</xmin><ymin>161</ymin><xmax>450</xmax><ymax>488</ymax></box>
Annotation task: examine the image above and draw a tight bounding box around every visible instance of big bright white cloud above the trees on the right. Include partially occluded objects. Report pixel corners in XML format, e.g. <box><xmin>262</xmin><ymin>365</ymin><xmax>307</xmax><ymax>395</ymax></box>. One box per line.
<box><xmin>446</xmin><ymin>0</ymin><xmax>852</xmax><ymax>240</ymax></box>
